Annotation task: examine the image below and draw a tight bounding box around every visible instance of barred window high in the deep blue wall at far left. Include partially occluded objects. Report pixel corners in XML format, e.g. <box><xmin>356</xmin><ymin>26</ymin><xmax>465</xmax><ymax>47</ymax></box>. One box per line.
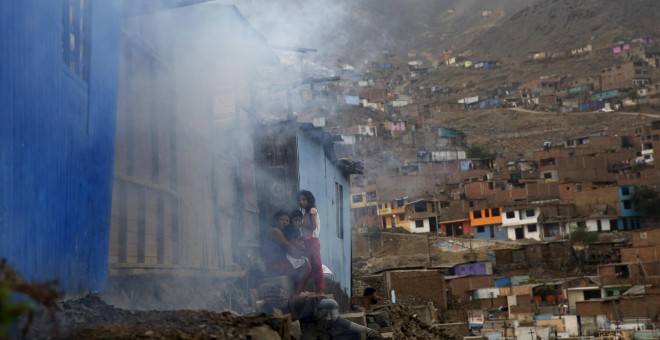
<box><xmin>61</xmin><ymin>0</ymin><xmax>91</xmax><ymax>83</ymax></box>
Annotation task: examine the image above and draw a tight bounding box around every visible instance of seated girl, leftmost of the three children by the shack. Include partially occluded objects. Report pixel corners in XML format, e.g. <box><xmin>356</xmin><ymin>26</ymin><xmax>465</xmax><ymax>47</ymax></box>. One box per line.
<box><xmin>263</xmin><ymin>210</ymin><xmax>310</xmax><ymax>297</ymax></box>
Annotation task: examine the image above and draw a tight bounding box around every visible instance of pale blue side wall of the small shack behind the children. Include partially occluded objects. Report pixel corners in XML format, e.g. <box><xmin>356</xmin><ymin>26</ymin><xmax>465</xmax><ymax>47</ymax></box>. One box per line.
<box><xmin>297</xmin><ymin>130</ymin><xmax>351</xmax><ymax>296</ymax></box>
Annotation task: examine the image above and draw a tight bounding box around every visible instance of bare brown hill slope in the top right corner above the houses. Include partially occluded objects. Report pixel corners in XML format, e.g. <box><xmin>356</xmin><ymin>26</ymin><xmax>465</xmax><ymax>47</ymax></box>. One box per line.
<box><xmin>468</xmin><ymin>0</ymin><xmax>660</xmax><ymax>58</ymax></box>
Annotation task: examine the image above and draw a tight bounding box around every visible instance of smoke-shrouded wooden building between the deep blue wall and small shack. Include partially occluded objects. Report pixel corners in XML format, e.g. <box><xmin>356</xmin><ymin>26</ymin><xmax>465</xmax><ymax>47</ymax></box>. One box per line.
<box><xmin>108</xmin><ymin>1</ymin><xmax>278</xmax><ymax>308</ymax></box>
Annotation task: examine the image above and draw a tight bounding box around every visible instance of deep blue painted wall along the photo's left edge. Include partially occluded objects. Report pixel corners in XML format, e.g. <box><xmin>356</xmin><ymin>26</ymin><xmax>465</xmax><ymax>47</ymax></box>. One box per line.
<box><xmin>0</xmin><ymin>0</ymin><xmax>121</xmax><ymax>295</ymax></box>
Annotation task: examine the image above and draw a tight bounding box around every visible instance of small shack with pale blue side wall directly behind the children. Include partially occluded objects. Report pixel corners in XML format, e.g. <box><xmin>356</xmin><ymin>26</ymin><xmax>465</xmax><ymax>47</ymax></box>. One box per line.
<box><xmin>255</xmin><ymin>121</ymin><xmax>362</xmax><ymax>306</ymax></box>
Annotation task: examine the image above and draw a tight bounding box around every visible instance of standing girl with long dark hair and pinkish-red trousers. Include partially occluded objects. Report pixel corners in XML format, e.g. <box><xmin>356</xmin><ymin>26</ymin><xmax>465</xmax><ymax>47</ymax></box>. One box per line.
<box><xmin>296</xmin><ymin>190</ymin><xmax>325</xmax><ymax>295</ymax></box>
